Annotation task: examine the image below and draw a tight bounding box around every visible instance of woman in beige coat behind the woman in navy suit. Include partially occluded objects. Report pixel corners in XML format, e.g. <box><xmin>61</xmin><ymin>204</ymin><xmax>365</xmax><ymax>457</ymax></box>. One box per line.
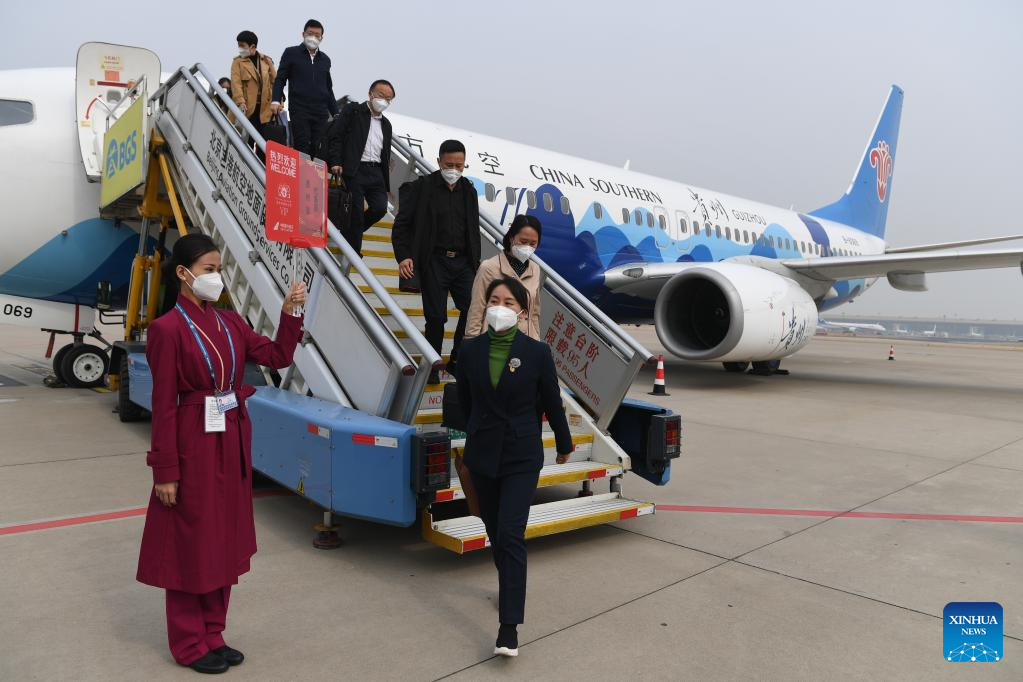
<box><xmin>465</xmin><ymin>215</ymin><xmax>543</xmax><ymax>340</ymax></box>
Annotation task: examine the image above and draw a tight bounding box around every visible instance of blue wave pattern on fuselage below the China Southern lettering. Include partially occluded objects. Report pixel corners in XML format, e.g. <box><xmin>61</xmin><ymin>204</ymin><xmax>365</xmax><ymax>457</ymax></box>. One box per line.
<box><xmin>473</xmin><ymin>179</ymin><xmax>865</xmax><ymax>322</ymax></box>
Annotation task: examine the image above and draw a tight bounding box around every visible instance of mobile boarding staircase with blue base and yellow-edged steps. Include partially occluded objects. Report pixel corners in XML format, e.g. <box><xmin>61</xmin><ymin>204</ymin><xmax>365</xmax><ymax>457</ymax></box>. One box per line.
<box><xmin>122</xmin><ymin>64</ymin><xmax>681</xmax><ymax>553</ymax></box>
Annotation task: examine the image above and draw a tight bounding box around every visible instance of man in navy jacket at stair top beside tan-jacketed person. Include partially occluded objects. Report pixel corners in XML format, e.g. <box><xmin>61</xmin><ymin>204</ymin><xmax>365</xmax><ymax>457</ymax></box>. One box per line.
<box><xmin>270</xmin><ymin>19</ymin><xmax>338</xmax><ymax>155</ymax></box>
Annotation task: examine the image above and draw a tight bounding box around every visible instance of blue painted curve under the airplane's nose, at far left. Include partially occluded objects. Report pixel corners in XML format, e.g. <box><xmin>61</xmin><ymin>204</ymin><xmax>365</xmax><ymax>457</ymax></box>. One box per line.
<box><xmin>0</xmin><ymin>218</ymin><xmax>138</xmax><ymax>307</ymax></box>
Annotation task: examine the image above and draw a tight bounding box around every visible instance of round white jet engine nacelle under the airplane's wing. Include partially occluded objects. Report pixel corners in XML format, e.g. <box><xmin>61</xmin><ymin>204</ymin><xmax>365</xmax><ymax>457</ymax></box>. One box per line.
<box><xmin>654</xmin><ymin>263</ymin><xmax>817</xmax><ymax>362</ymax></box>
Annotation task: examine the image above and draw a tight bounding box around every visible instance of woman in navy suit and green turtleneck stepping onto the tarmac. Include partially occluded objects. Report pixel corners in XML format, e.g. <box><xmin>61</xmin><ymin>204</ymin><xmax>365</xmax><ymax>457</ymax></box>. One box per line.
<box><xmin>457</xmin><ymin>278</ymin><xmax>574</xmax><ymax>656</ymax></box>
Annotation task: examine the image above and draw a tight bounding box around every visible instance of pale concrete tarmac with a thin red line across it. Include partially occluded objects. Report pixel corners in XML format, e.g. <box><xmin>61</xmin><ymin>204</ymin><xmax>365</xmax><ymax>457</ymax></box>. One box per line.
<box><xmin>0</xmin><ymin>327</ymin><xmax>1023</xmax><ymax>681</ymax></box>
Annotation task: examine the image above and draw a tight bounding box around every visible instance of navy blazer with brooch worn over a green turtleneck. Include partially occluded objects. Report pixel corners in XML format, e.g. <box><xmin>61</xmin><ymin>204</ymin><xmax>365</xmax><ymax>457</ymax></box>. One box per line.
<box><xmin>457</xmin><ymin>332</ymin><xmax>573</xmax><ymax>479</ymax></box>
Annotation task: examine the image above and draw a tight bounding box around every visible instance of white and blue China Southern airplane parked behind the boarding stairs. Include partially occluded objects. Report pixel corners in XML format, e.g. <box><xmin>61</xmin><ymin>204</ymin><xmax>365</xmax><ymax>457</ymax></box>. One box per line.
<box><xmin>0</xmin><ymin>43</ymin><xmax>1023</xmax><ymax>384</ymax></box>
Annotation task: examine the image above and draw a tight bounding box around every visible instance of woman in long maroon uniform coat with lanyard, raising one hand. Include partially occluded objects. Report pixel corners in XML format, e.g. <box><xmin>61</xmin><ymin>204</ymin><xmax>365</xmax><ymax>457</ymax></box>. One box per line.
<box><xmin>137</xmin><ymin>234</ymin><xmax>306</xmax><ymax>673</ymax></box>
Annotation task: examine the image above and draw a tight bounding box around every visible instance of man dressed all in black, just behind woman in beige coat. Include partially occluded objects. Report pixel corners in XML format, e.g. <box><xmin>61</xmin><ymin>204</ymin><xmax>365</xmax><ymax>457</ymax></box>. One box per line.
<box><xmin>392</xmin><ymin>140</ymin><xmax>480</xmax><ymax>383</ymax></box>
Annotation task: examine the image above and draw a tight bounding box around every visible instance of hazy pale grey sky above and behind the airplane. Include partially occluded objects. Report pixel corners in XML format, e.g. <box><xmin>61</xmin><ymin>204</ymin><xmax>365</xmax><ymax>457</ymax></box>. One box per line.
<box><xmin>0</xmin><ymin>0</ymin><xmax>1023</xmax><ymax>319</ymax></box>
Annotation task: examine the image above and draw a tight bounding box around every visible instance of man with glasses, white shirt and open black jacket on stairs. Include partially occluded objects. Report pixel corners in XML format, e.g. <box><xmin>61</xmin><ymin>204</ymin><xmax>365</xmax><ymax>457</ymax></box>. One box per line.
<box><xmin>324</xmin><ymin>80</ymin><xmax>394</xmax><ymax>256</ymax></box>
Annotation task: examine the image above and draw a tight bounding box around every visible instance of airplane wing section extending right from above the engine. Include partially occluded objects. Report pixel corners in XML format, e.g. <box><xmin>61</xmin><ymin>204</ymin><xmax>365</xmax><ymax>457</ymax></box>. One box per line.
<box><xmin>781</xmin><ymin>248</ymin><xmax>1023</xmax><ymax>280</ymax></box>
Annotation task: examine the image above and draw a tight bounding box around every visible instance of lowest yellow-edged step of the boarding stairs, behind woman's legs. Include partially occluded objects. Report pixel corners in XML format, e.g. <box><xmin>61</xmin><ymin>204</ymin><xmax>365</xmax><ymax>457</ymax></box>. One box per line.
<box><xmin>422</xmin><ymin>493</ymin><xmax>654</xmax><ymax>554</ymax></box>
